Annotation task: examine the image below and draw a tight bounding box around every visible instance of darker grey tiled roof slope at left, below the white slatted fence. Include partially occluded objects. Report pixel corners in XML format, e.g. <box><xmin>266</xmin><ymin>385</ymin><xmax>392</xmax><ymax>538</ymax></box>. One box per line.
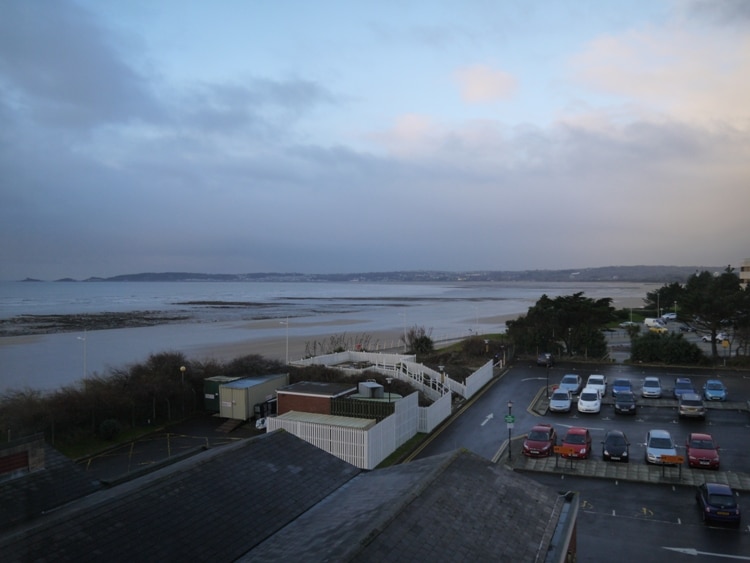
<box><xmin>0</xmin><ymin>431</ymin><xmax>360</xmax><ymax>562</ymax></box>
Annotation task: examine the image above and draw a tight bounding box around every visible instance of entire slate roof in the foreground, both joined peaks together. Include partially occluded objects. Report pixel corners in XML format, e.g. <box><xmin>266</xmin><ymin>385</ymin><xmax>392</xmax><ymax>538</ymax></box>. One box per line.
<box><xmin>0</xmin><ymin>430</ymin><xmax>576</xmax><ymax>563</ymax></box>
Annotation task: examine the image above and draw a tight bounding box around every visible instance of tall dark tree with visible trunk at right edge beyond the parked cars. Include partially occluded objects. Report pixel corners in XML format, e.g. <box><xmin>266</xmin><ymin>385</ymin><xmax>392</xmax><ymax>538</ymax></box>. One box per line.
<box><xmin>680</xmin><ymin>266</ymin><xmax>748</xmax><ymax>360</ymax></box>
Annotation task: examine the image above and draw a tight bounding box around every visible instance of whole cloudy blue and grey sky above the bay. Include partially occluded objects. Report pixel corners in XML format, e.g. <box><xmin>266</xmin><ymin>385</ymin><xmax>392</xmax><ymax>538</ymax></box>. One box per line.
<box><xmin>0</xmin><ymin>0</ymin><xmax>750</xmax><ymax>280</ymax></box>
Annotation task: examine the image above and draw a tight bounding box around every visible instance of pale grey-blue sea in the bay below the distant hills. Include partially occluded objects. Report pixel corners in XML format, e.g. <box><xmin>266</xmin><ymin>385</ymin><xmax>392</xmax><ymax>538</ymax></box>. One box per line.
<box><xmin>0</xmin><ymin>281</ymin><xmax>658</xmax><ymax>394</ymax></box>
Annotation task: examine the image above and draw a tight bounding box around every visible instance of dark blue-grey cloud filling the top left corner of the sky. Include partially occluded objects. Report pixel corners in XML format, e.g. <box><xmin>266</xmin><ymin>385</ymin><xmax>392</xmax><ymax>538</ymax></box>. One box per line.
<box><xmin>0</xmin><ymin>2</ymin><xmax>160</xmax><ymax>127</ymax></box>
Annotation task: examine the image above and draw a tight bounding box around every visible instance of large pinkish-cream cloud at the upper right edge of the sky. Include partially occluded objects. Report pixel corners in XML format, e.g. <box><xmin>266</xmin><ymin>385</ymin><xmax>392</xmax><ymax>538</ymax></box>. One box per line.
<box><xmin>570</xmin><ymin>28</ymin><xmax>750</xmax><ymax>130</ymax></box>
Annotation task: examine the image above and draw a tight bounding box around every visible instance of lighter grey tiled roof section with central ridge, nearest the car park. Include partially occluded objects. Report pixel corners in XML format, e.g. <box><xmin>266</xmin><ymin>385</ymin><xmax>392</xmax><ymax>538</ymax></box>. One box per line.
<box><xmin>250</xmin><ymin>451</ymin><xmax>562</xmax><ymax>563</ymax></box>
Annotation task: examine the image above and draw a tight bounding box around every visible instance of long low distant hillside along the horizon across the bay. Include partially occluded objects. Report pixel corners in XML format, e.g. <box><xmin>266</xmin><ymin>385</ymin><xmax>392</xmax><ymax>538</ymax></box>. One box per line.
<box><xmin>39</xmin><ymin>266</ymin><xmax>726</xmax><ymax>283</ymax></box>
